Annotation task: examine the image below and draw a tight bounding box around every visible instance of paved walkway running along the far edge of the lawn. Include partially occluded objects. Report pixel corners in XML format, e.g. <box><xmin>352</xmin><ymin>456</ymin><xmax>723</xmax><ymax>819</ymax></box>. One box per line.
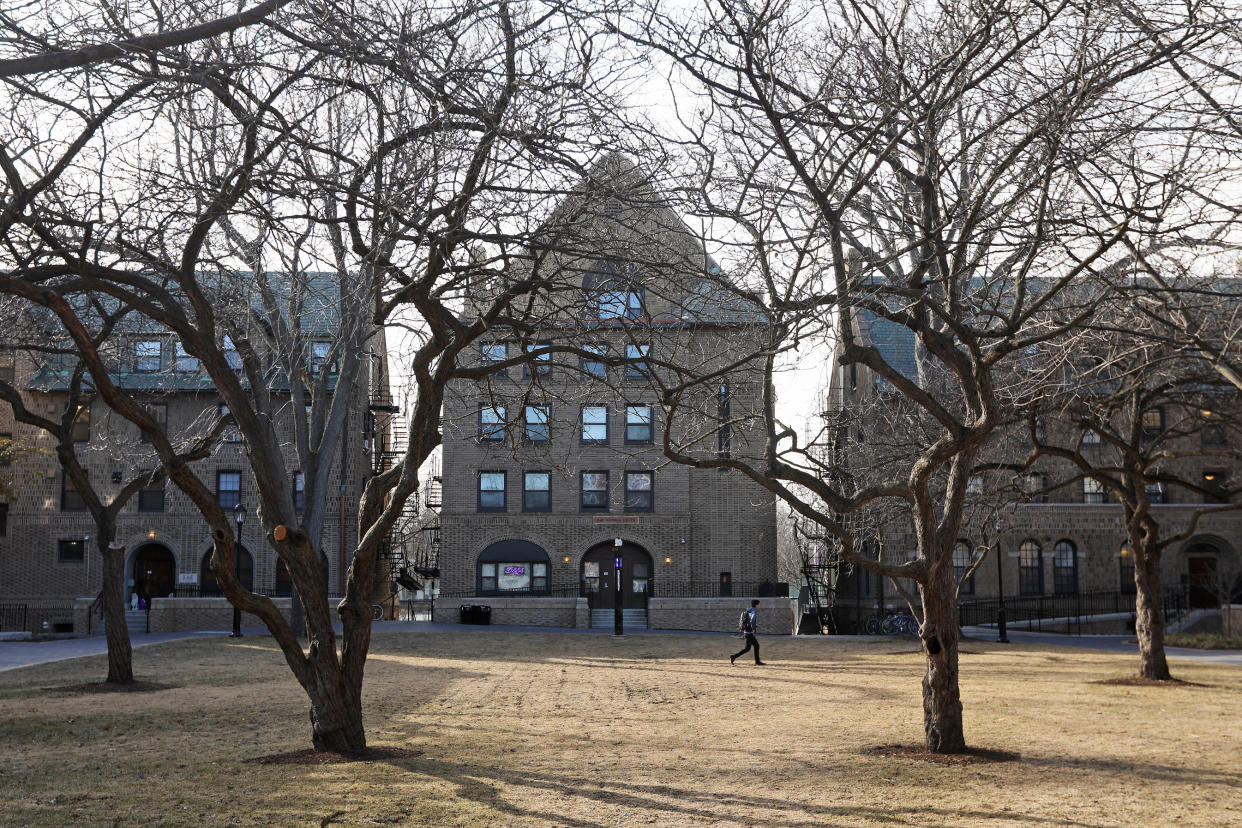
<box><xmin>0</xmin><ymin>621</ymin><xmax>1242</xmax><ymax>672</ymax></box>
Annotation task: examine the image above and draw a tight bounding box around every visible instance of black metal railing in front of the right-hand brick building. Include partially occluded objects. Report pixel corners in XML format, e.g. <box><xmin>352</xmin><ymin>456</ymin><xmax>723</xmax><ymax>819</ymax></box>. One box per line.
<box><xmin>958</xmin><ymin>588</ymin><xmax>1190</xmax><ymax>634</ymax></box>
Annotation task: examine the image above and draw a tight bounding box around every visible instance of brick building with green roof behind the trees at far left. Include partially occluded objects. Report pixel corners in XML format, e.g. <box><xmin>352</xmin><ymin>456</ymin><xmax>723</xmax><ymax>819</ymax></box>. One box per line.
<box><xmin>0</xmin><ymin>279</ymin><xmax>391</xmax><ymax>632</ymax></box>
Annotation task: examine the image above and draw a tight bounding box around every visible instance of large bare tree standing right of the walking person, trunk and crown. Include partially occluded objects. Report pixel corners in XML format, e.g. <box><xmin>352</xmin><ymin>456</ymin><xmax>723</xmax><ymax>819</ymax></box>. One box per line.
<box><xmin>636</xmin><ymin>2</ymin><xmax>1211</xmax><ymax>752</ymax></box>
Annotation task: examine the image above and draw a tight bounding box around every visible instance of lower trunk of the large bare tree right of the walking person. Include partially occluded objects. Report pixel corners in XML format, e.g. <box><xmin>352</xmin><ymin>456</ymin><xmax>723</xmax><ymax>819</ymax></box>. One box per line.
<box><xmin>919</xmin><ymin>555</ymin><xmax>966</xmax><ymax>754</ymax></box>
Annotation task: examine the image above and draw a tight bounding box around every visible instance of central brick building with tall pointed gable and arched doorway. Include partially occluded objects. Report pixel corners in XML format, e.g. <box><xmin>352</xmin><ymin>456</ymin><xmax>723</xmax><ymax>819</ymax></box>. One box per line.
<box><xmin>436</xmin><ymin>158</ymin><xmax>790</xmax><ymax>629</ymax></box>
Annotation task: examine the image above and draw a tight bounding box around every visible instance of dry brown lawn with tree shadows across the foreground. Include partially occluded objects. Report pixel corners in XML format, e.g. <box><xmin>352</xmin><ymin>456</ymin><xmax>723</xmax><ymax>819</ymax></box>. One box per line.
<box><xmin>0</xmin><ymin>631</ymin><xmax>1242</xmax><ymax>827</ymax></box>
